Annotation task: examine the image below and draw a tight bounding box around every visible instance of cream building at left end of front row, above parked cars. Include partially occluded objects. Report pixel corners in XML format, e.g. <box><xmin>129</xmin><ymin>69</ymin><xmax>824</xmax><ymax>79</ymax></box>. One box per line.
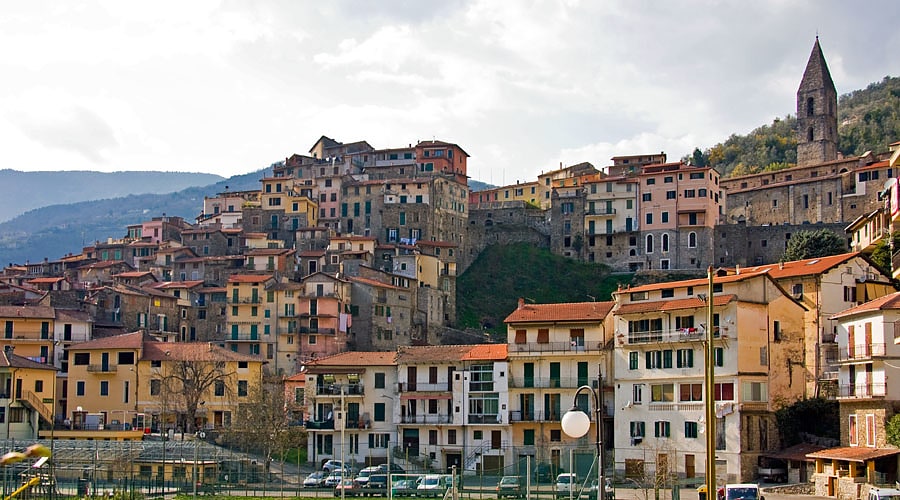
<box><xmin>303</xmin><ymin>351</ymin><xmax>400</xmax><ymax>468</ymax></box>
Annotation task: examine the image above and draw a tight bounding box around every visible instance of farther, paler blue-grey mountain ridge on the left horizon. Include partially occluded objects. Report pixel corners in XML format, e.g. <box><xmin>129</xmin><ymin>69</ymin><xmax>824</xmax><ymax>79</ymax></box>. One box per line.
<box><xmin>0</xmin><ymin>169</ymin><xmax>225</xmax><ymax>222</ymax></box>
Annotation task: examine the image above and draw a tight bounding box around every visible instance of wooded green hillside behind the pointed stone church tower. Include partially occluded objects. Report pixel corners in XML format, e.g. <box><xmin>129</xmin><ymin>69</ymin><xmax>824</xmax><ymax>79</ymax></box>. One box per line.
<box><xmin>684</xmin><ymin>76</ymin><xmax>900</xmax><ymax>177</ymax></box>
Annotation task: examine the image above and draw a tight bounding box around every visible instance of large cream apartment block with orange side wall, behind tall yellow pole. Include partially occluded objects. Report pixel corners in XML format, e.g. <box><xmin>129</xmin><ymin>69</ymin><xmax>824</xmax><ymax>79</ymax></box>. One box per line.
<box><xmin>612</xmin><ymin>271</ymin><xmax>814</xmax><ymax>482</ymax></box>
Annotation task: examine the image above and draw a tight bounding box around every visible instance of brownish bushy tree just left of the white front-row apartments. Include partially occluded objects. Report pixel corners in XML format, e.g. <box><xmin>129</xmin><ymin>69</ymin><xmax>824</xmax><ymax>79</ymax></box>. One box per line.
<box><xmin>226</xmin><ymin>377</ymin><xmax>305</xmax><ymax>470</ymax></box>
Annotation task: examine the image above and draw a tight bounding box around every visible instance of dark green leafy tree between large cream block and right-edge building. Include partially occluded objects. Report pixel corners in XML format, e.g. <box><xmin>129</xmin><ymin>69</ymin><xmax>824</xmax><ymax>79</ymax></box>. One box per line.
<box><xmin>775</xmin><ymin>398</ymin><xmax>841</xmax><ymax>448</ymax></box>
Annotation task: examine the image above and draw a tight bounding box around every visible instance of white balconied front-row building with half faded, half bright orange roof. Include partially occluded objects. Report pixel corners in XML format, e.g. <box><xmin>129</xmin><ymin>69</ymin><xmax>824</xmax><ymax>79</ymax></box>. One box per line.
<box><xmin>393</xmin><ymin>344</ymin><xmax>514</xmax><ymax>473</ymax></box>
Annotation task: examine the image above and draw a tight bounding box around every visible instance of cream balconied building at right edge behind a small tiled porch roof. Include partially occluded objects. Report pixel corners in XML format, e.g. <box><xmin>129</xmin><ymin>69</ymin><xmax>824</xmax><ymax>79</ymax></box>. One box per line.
<box><xmin>809</xmin><ymin>293</ymin><xmax>900</xmax><ymax>498</ymax></box>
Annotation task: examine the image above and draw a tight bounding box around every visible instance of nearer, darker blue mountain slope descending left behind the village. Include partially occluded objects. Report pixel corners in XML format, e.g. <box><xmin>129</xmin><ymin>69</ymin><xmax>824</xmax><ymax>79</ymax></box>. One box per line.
<box><xmin>0</xmin><ymin>169</ymin><xmax>272</xmax><ymax>267</ymax></box>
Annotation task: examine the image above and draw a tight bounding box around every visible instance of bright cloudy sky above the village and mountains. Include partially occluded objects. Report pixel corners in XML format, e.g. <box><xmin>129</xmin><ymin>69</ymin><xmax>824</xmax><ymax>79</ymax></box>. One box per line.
<box><xmin>0</xmin><ymin>0</ymin><xmax>900</xmax><ymax>185</ymax></box>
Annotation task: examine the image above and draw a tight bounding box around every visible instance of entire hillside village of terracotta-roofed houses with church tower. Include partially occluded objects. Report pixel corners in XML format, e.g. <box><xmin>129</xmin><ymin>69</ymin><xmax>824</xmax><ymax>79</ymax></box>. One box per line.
<box><xmin>0</xmin><ymin>40</ymin><xmax>900</xmax><ymax>496</ymax></box>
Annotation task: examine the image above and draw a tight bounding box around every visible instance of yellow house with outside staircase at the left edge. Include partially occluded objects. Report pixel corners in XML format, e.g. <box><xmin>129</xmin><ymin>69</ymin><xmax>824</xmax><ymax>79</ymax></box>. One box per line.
<box><xmin>0</xmin><ymin>346</ymin><xmax>56</xmax><ymax>440</ymax></box>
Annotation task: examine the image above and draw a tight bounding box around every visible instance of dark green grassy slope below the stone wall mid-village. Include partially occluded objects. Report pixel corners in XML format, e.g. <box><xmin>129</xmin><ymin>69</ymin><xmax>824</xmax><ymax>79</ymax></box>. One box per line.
<box><xmin>456</xmin><ymin>243</ymin><xmax>632</xmax><ymax>339</ymax></box>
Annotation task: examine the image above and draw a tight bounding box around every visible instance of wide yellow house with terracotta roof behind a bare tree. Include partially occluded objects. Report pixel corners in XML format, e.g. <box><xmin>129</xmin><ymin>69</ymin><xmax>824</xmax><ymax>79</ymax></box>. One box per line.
<box><xmin>64</xmin><ymin>331</ymin><xmax>263</xmax><ymax>439</ymax></box>
